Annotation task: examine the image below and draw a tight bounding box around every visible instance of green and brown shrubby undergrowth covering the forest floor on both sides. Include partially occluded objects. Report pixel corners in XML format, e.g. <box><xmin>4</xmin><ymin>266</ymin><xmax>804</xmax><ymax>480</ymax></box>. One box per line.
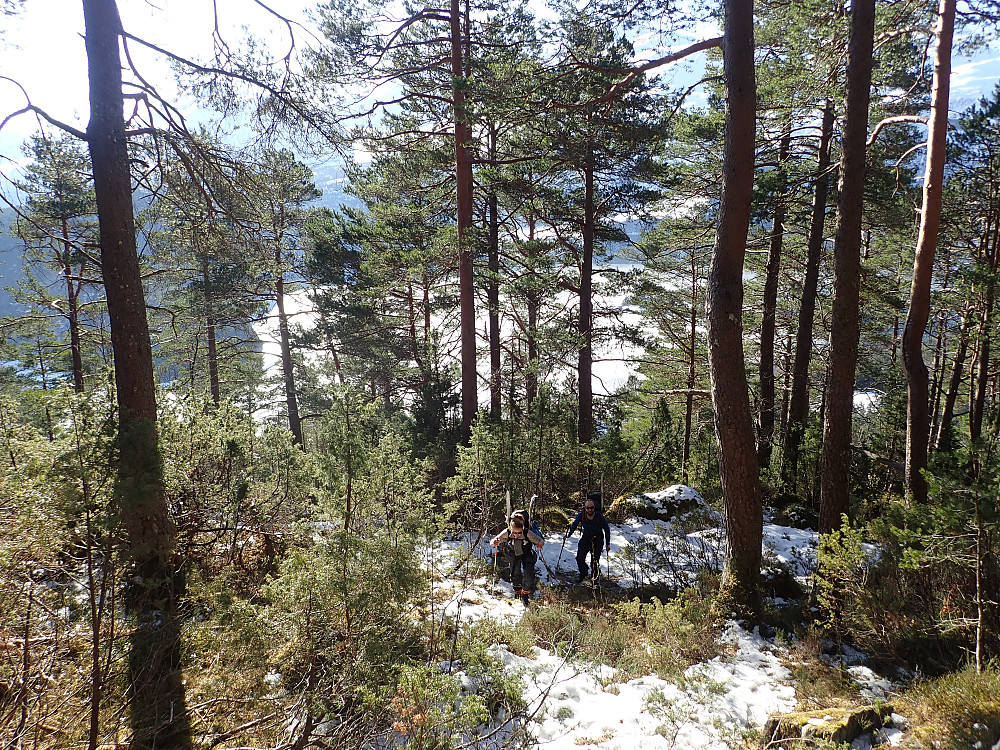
<box><xmin>0</xmin><ymin>390</ymin><xmax>1000</xmax><ymax>748</ymax></box>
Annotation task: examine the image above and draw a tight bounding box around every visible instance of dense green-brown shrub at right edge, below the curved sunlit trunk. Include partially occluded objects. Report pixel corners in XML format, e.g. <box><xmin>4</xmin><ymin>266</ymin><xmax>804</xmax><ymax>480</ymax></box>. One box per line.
<box><xmin>816</xmin><ymin>488</ymin><xmax>1000</xmax><ymax>674</ymax></box>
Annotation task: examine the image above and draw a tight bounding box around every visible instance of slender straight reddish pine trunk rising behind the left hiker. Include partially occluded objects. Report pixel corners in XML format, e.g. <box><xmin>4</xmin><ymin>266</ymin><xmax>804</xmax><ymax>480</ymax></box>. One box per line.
<box><xmin>450</xmin><ymin>0</ymin><xmax>479</xmax><ymax>444</ymax></box>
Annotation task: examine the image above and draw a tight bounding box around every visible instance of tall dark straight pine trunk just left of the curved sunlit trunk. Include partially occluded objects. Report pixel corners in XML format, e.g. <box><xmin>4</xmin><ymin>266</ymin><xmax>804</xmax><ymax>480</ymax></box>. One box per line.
<box><xmin>819</xmin><ymin>0</ymin><xmax>875</xmax><ymax>533</ymax></box>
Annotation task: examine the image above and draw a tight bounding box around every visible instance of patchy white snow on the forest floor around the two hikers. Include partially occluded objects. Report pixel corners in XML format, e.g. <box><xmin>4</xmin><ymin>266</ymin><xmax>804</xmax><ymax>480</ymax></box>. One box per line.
<box><xmin>426</xmin><ymin>488</ymin><xmax>899</xmax><ymax>750</ymax></box>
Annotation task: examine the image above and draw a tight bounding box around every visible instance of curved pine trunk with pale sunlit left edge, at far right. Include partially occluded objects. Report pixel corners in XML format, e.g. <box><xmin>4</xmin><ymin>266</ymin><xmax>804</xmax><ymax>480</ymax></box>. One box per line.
<box><xmin>903</xmin><ymin>0</ymin><xmax>956</xmax><ymax>503</ymax></box>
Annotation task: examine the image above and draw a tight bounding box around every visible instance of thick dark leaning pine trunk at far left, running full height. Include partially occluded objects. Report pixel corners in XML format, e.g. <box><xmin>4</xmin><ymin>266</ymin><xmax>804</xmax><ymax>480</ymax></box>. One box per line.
<box><xmin>83</xmin><ymin>0</ymin><xmax>191</xmax><ymax>750</ymax></box>
